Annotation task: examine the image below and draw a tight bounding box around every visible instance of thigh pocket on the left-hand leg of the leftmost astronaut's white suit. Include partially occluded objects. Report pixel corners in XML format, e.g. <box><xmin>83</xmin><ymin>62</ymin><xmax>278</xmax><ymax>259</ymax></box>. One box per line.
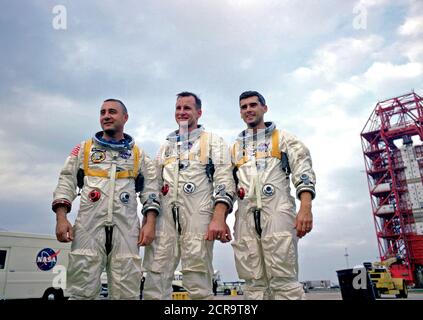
<box><xmin>67</xmin><ymin>250</ymin><xmax>103</xmax><ymax>298</ymax></box>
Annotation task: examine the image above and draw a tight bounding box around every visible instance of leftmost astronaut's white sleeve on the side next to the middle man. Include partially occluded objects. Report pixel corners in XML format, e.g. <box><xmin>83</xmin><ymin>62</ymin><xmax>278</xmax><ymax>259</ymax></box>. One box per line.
<box><xmin>140</xmin><ymin>152</ymin><xmax>160</xmax><ymax>215</ymax></box>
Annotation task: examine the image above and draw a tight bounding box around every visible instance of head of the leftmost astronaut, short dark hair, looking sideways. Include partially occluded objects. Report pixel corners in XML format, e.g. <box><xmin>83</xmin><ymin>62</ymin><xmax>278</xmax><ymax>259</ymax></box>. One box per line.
<box><xmin>100</xmin><ymin>101</ymin><xmax>128</xmax><ymax>135</ymax></box>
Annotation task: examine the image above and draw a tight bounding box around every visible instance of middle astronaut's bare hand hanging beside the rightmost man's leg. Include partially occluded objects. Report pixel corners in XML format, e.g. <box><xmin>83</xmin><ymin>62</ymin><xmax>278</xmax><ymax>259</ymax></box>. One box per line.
<box><xmin>204</xmin><ymin>203</ymin><xmax>232</xmax><ymax>243</ymax></box>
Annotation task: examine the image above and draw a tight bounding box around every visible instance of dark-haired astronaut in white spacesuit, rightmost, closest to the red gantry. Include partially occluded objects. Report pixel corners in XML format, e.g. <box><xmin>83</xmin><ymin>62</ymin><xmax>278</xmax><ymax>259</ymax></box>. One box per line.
<box><xmin>232</xmin><ymin>91</ymin><xmax>316</xmax><ymax>300</ymax></box>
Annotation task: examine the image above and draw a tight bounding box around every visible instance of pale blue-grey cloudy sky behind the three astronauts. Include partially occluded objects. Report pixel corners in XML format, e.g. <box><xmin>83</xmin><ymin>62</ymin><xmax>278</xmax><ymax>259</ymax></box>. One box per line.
<box><xmin>0</xmin><ymin>0</ymin><xmax>423</xmax><ymax>281</ymax></box>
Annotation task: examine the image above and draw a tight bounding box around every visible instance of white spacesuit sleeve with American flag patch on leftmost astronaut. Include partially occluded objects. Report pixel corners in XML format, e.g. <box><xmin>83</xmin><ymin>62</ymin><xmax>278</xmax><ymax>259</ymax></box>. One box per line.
<box><xmin>52</xmin><ymin>142</ymin><xmax>85</xmax><ymax>212</ymax></box>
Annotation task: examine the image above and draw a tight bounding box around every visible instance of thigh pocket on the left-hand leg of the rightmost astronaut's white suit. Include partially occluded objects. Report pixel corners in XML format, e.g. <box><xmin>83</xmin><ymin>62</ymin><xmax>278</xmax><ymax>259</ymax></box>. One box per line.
<box><xmin>232</xmin><ymin>238</ymin><xmax>263</xmax><ymax>280</ymax></box>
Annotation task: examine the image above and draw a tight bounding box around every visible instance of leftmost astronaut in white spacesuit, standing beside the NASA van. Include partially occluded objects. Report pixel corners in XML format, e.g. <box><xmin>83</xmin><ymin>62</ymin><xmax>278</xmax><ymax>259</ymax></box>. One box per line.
<box><xmin>52</xmin><ymin>99</ymin><xmax>160</xmax><ymax>299</ymax></box>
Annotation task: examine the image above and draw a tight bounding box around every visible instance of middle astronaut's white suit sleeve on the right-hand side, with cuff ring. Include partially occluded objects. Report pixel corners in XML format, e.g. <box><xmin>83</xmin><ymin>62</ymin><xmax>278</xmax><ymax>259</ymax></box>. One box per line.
<box><xmin>209</xmin><ymin>134</ymin><xmax>235</xmax><ymax>213</ymax></box>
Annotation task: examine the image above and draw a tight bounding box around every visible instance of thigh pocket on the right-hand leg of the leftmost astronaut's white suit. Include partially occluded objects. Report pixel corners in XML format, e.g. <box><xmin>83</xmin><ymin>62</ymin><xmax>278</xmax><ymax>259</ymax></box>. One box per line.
<box><xmin>110</xmin><ymin>254</ymin><xmax>142</xmax><ymax>299</ymax></box>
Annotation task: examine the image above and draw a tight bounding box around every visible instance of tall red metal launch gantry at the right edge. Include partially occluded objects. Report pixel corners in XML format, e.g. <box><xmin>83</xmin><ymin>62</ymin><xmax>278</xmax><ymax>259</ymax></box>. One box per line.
<box><xmin>361</xmin><ymin>92</ymin><xmax>423</xmax><ymax>287</ymax></box>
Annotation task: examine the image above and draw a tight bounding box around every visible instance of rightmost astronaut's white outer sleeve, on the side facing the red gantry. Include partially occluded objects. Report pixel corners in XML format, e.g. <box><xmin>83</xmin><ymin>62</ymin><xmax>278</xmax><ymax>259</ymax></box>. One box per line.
<box><xmin>281</xmin><ymin>132</ymin><xmax>316</xmax><ymax>199</ymax></box>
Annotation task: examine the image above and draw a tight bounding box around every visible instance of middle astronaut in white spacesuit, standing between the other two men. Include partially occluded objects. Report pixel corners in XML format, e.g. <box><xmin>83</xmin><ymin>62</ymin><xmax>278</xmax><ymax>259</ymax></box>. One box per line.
<box><xmin>143</xmin><ymin>92</ymin><xmax>235</xmax><ymax>300</ymax></box>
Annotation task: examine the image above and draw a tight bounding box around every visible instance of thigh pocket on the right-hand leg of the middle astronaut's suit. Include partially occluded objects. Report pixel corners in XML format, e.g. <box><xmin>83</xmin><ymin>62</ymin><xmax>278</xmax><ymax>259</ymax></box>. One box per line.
<box><xmin>181</xmin><ymin>234</ymin><xmax>211</xmax><ymax>272</ymax></box>
